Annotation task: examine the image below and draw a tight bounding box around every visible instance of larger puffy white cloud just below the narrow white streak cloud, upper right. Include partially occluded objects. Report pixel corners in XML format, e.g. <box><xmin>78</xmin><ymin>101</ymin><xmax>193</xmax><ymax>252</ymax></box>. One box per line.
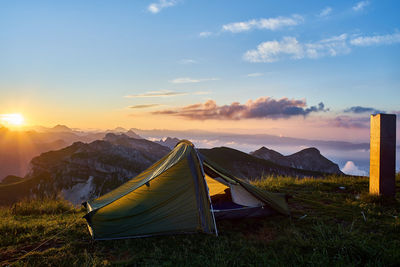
<box><xmin>243</xmin><ymin>34</ymin><xmax>350</xmax><ymax>63</ymax></box>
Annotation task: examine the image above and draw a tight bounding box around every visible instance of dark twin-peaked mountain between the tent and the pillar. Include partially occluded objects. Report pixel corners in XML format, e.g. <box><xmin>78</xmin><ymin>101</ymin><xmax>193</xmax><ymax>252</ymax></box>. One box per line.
<box><xmin>250</xmin><ymin>146</ymin><xmax>343</xmax><ymax>175</ymax></box>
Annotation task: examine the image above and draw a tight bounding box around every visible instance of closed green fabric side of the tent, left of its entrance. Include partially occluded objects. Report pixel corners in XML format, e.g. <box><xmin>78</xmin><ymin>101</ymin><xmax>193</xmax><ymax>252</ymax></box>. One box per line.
<box><xmin>84</xmin><ymin>143</ymin><xmax>216</xmax><ymax>239</ymax></box>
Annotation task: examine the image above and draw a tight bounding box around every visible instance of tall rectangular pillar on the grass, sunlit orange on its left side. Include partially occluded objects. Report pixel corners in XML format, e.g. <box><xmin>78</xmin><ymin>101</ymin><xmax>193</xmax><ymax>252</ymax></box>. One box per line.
<box><xmin>369</xmin><ymin>114</ymin><xmax>396</xmax><ymax>196</ymax></box>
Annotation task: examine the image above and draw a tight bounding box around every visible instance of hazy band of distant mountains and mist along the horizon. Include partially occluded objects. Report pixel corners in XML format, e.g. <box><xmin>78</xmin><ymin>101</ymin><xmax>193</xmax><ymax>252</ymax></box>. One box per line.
<box><xmin>0</xmin><ymin>124</ymin><xmax>372</xmax><ymax>181</ymax></box>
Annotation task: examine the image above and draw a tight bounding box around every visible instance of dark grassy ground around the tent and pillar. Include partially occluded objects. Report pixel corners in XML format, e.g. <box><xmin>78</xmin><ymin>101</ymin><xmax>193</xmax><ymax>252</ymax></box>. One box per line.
<box><xmin>0</xmin><ymin>175</ymin><xmax>400</xmax><ymax>266</ymax></box>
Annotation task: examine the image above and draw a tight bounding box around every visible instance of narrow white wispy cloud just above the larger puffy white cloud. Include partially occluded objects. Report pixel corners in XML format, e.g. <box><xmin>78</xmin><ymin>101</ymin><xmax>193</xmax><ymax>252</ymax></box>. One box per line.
<box><xmin>222</xmin><ymin>15</ymin><xmax>304</xmax><ymax>33</ymax></box>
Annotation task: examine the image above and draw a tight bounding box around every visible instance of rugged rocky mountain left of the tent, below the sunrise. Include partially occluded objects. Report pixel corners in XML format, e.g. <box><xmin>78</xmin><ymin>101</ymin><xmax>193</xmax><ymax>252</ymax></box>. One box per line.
<box><xmin>0</xmin><ymin>133</ymin><xmax>170</xmax><ymax>204</ymax></box>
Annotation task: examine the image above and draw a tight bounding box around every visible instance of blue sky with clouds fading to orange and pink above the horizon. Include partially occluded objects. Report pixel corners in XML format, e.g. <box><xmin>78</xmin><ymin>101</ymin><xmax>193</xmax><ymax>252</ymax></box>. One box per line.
<box><xmin>0</xmin><ymin>0</ymin><xmax>400</xmax><ymax>142</ymax></box>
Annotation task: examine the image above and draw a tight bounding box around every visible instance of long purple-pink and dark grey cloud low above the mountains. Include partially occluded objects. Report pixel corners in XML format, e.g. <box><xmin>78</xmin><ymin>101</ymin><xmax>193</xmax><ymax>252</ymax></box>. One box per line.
<box><xmin>152</xmin><ymin>97</ymin><xmax>328</xmax><ymax>120</ymax></box>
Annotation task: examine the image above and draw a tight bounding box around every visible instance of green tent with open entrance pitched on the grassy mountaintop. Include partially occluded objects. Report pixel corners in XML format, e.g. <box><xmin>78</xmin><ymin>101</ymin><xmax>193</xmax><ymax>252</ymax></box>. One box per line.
<box><xmin>83</xmin><ymin>140</ymin><xmax>289</xmax><ymax>240</ymax></box>
